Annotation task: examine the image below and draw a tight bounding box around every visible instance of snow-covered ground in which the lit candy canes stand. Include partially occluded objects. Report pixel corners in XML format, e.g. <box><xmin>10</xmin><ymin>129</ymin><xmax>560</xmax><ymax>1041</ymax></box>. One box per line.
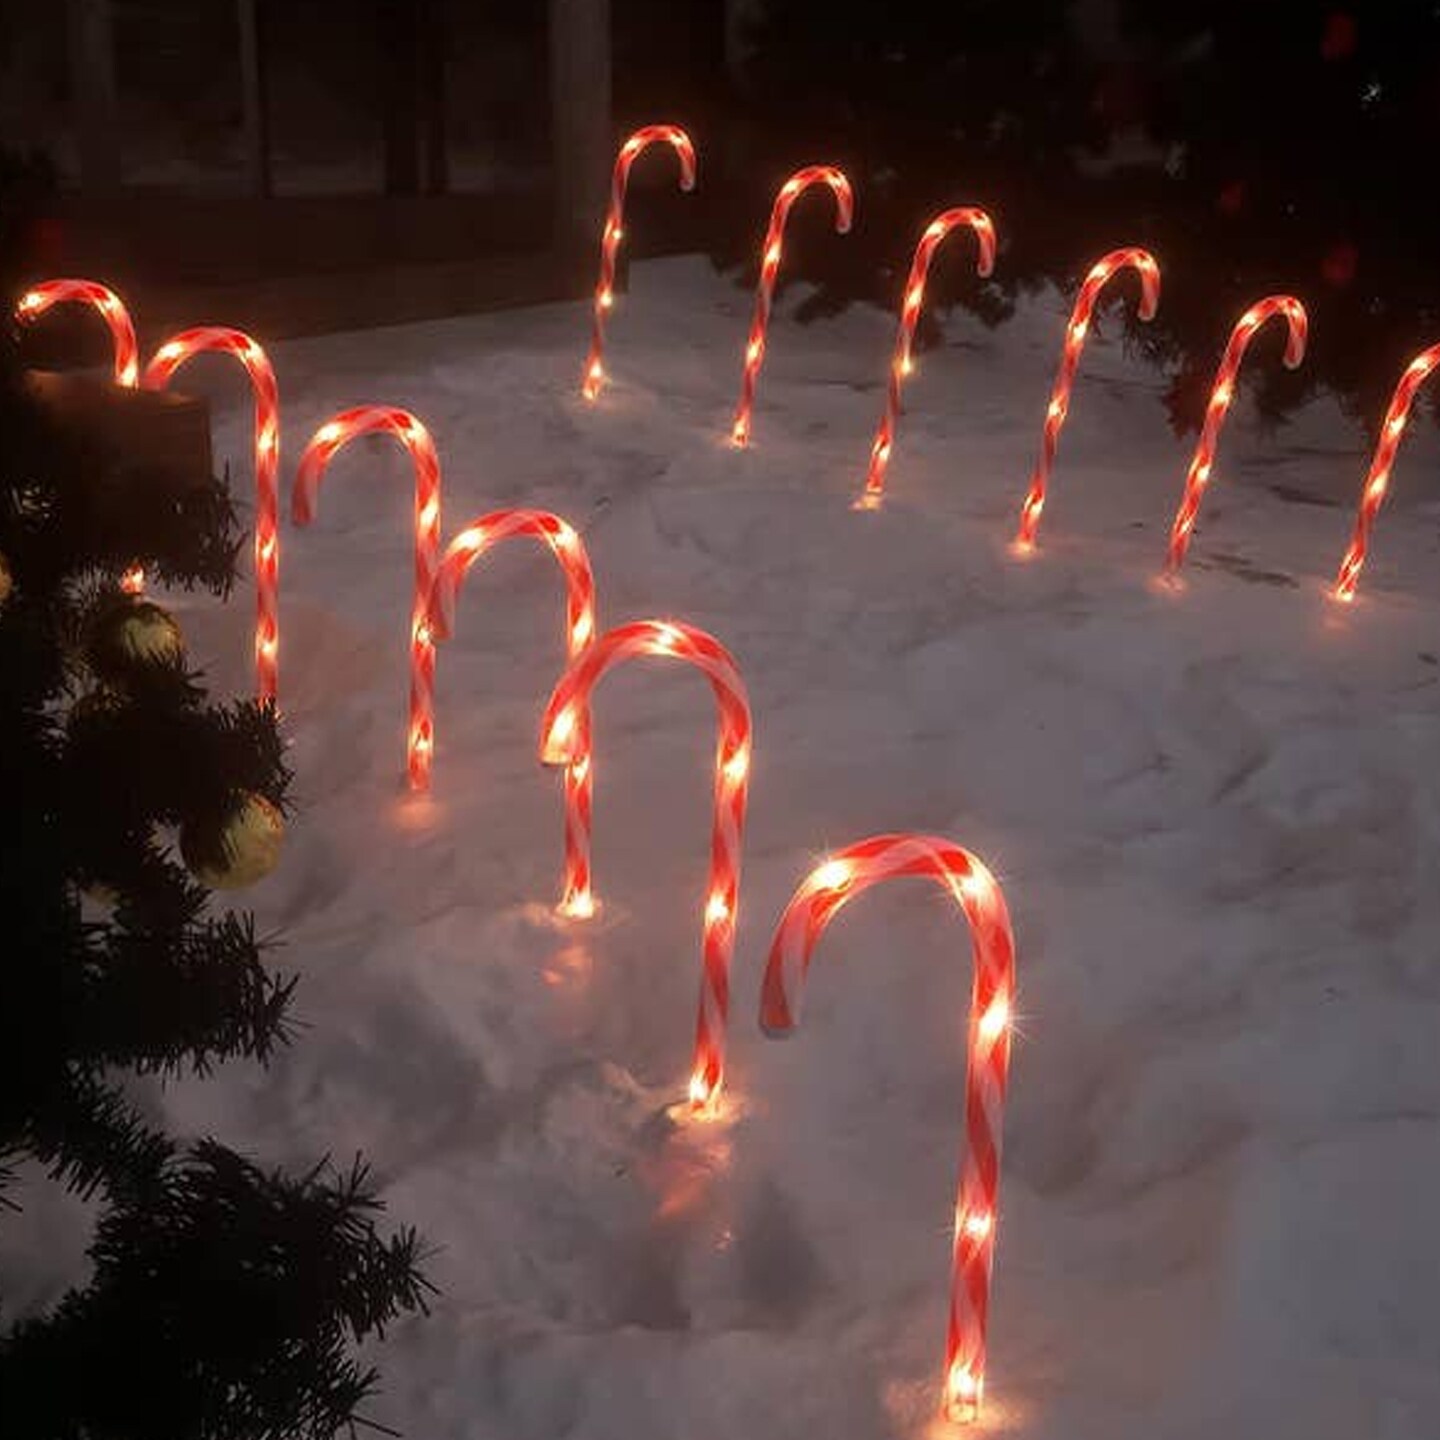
<box><xmin>25</xmin><ymin>259</ymin><xmax>1440</xmax><ymax>1440</ymax></box>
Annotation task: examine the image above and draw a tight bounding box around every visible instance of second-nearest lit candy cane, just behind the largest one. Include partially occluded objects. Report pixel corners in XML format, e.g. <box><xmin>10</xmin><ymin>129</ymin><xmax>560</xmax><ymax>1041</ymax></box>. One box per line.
<box><xmin>540</xmin><ymin>621</ymin><xmax>750</xmax><ymax>1113</ymax></box>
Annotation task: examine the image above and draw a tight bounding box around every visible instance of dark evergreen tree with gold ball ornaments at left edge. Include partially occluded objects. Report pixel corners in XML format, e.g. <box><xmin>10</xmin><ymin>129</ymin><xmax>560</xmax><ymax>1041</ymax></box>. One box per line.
<box><xmin>0</xmin><ymin>149</ymin><xmax>425</xmax><ymax>1440</ymax></box>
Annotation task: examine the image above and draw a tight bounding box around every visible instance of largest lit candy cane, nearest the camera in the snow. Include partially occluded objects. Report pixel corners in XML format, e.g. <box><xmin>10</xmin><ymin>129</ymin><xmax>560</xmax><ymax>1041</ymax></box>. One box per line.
<box><xmin>760</xmin><ymin>835</ymin><xmax>1015</xmax><ymax>1421</ymax></box>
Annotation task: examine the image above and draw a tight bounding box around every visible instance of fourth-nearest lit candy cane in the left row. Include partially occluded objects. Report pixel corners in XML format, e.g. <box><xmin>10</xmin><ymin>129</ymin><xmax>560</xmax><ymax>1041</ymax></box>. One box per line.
<box><xmin>291</xmin><ymin>405</ymin><xmax>441</xmax><ymax>791</ymax></box>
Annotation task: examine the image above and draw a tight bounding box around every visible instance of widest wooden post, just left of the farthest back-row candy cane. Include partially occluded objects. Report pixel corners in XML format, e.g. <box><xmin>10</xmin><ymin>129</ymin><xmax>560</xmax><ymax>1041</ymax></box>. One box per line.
<box><xmin>550</xmin><ymin>0</ymin><xmax>604</xmax><ymax>256</ymax></box>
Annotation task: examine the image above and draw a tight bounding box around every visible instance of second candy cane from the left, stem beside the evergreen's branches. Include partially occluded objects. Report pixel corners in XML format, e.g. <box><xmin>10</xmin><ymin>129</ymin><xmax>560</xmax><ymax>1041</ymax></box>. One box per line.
<box><xmin>145</xmin><ymin>325</ymin><xmax>279</xmax><ymax>701</ymax></box>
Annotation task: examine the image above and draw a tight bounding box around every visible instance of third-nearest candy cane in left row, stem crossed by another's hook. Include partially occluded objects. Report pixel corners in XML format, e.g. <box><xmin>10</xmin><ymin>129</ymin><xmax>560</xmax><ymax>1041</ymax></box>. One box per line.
<box><xmin>429</xmin><ymin>510</ymin><xmax>595</xmax><ymax>919</ymax></box>
